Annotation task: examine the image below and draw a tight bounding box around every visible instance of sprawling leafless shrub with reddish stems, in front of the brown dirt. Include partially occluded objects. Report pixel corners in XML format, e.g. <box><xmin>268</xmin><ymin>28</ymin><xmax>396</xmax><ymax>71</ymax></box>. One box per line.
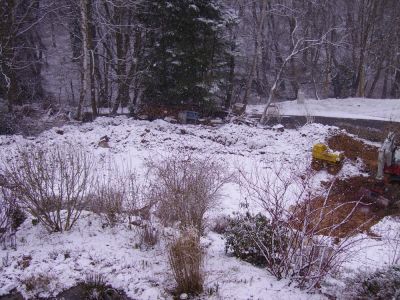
<box><xmin>236</xmin><ymin>168</ymin><xmax>368</xmax><ymax>289</ymax></box>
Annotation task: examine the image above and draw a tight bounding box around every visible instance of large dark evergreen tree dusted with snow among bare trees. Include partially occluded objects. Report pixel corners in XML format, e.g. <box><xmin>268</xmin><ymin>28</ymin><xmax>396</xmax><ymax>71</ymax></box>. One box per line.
<box><xmin>140</xmin><ymin>0</ymin><xmax>231</xmax><ymax>112</ymax></box>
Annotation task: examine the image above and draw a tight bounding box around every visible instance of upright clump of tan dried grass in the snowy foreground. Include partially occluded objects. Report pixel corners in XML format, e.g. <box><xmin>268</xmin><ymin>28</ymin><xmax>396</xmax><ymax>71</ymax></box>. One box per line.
<box><xmin>169</xmin><ymin>228</ymin><xmax>204</xmax><ymax>295</ymax></box>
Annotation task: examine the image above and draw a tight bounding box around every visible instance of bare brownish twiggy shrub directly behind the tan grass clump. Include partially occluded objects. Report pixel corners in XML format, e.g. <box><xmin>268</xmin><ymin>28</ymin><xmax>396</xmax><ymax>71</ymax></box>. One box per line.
<box><xmin>150</xmin><ymin>156</ymin><xmax>230</xmax><ymax>233</ymax></box>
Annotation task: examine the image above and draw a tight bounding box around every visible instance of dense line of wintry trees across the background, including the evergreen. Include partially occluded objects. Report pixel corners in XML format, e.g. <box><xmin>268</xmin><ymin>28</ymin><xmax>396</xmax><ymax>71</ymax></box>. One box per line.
<box><xmin>0</xmin><ymin>0</ymin><xmax>400</xmax><ymax>119</ymax></box>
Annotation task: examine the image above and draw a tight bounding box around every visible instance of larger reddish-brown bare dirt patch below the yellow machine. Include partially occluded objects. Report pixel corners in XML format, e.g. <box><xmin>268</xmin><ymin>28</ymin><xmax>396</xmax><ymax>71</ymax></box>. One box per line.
<box><xmin>294</xmin><ymin>176</ymin><xmax>399</xmax><ymax>238</ymax></box>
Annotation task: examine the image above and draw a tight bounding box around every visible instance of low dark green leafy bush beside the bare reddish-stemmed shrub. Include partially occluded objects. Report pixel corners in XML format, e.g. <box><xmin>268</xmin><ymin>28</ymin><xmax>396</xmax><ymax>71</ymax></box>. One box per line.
<box><xmin>224</xmin><ymin>213</ymin><xmax>288</xmax><ymax>267</ymax></box>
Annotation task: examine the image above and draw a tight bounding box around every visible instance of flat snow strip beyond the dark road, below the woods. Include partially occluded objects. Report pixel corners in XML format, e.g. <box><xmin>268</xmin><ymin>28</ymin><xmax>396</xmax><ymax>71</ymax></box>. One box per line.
<box><xmin>247</xmin><ymin>98</ymin><xmax>400</xmax><ymax>122</ymax></box>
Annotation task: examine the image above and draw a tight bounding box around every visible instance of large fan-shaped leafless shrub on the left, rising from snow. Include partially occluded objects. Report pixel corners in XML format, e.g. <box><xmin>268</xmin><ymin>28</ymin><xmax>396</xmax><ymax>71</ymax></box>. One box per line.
<box><xmin>3</xmin><ymin>145</ymin><xmax>94</xmax><ymax>232</ymax></box>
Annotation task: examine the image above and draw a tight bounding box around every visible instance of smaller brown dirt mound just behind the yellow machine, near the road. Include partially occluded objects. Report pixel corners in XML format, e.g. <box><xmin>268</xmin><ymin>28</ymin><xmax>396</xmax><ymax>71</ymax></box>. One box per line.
<box><xmin>328</xmin><ymin>134</ymin><xmax>378</xmax><ymax>175</ymax></box>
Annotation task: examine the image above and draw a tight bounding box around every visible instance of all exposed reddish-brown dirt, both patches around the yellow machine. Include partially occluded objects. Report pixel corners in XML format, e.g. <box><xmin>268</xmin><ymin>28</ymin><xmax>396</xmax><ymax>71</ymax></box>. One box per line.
<box><xmin>296</xmin><ymin>134</ymin><xmax>400</xmax><ymax>237</ymax></box>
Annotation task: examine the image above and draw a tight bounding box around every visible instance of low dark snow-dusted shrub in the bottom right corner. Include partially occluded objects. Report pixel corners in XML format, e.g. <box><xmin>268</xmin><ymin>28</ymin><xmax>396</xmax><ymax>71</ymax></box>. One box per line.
<box><xmin>345</xmin><ymin>265</ymin><xmax>400</xmax><ymax>300</ymax></box>
